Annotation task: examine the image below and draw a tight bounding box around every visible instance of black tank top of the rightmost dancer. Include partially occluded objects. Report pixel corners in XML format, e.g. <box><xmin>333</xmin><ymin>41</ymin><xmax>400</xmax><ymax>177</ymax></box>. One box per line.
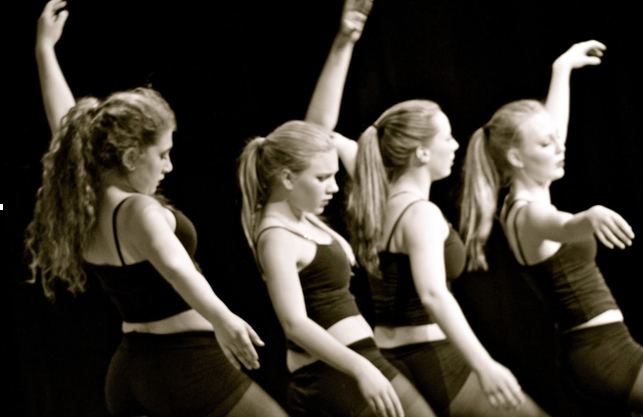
<box><xmin>504</xmin><ymin>199</ymin><xmax>618</xmax><ymax>331</ymax></box>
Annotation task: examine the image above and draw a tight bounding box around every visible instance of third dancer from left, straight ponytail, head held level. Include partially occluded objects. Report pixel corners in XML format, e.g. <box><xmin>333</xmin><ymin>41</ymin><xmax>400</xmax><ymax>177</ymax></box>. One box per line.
<box><xmin>348</xmin><ymin>100</ymin><xmax>546</xmax><ymax>416</ymax></box>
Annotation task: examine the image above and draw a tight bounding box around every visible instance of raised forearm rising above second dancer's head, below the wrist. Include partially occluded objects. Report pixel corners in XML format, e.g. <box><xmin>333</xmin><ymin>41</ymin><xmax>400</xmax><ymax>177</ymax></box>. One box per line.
<box><xmin>305</xmin><ymin>34</ymin><xmax>355</xmax><ymax>130</ymax></box>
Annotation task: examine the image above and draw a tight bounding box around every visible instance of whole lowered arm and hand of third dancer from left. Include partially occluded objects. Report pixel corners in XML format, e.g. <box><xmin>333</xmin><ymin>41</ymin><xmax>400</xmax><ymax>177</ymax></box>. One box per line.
<box><xmin>410</xmin><ymin>203</ymin><xmax>525</xmax><ymax>407</ymax></box>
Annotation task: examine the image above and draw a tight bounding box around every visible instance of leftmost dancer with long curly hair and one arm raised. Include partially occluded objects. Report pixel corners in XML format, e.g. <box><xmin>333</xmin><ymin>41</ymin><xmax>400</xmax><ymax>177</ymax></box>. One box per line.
<box><xmin>27</xmin><ymin>0</ymin><xmax>287</xmax><ymax>417</ymax></box>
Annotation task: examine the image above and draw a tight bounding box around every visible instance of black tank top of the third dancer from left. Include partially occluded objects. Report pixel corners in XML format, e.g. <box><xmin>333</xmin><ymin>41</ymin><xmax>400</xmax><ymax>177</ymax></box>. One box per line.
<box><xmin>369</xmin><ymin>200</ymin><xmax>465</xmax><ymax>327</ymax></box>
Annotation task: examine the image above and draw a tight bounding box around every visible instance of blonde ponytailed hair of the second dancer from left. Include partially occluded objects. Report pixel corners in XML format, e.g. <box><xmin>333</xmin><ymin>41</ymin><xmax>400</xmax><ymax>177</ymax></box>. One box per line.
<box><xmin>237</xmin><ymin>120</ymin><xmax>333</xmax><ymax>259</ymax></box>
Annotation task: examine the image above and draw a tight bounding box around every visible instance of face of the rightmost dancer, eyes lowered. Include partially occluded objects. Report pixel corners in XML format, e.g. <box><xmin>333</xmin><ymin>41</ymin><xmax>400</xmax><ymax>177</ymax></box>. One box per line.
<box><xmin>510</xmin><ymin>111</ymin><xmax>565</xmax><ymax>184</ymax></box>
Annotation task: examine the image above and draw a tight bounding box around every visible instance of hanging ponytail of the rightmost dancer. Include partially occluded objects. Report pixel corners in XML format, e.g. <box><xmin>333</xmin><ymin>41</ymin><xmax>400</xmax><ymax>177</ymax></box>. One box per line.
<box><xmin>460</xmin><ymin>127</ymin><xmax>500</xmax><ymax>271</ymax></box>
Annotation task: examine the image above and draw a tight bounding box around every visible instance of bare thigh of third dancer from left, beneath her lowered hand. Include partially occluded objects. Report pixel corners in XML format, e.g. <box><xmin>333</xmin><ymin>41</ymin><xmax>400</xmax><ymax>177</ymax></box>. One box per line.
<box><xmin>449</xmin><ymin>372</ymin><xmax>548</xmax><ymax>417</ymax></box>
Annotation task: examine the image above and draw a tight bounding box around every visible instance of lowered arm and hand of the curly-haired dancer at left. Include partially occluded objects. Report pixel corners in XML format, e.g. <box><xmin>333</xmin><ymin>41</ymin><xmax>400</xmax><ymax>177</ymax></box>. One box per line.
<box><xmin>121</xmin><ymin>196</ymin><xmax>263</xmax><ymax>369</ymax></box>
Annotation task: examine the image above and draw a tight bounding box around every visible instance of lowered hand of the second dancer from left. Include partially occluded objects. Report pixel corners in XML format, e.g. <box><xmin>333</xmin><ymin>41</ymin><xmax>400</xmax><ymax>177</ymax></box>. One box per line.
<box><xmin>357</xmin><ymin>359</ymin><xmax>404</xmax><ymax>417</ymax></box>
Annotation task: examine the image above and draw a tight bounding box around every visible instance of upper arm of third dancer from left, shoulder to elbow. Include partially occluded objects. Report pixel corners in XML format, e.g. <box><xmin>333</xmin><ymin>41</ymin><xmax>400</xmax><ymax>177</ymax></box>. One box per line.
<box><xmin>401</xmin><ymin>202</ymin><xmax>448</xmax><ymax>299</ymax></box>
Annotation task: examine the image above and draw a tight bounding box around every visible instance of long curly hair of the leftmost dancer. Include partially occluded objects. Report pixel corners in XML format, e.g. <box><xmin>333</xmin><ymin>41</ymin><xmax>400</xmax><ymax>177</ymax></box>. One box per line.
<box><xmin>25</xmin><ymin>88</ymin><xmax>176</xmax><ymax>299</ymax></box>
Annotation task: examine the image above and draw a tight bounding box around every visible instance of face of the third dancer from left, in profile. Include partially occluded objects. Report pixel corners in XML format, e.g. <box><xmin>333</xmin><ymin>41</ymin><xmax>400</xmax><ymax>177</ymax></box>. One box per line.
<box><xmin>428</xmin><ymin>112</ymin><xmax>460</xmax><ymax>181</ymax></box>
